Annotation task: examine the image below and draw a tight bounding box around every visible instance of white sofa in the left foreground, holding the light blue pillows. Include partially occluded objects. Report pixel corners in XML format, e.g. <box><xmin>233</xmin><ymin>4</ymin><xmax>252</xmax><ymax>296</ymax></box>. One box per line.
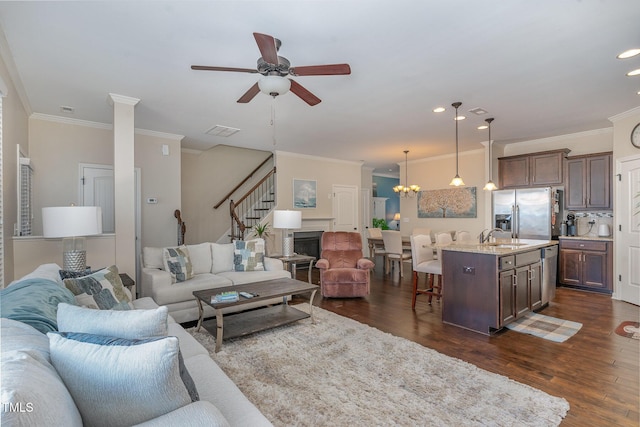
<box><xmin>0</xmin><ymin>264</ymin><xmax>271</xmax><ymax>426</ymax></box>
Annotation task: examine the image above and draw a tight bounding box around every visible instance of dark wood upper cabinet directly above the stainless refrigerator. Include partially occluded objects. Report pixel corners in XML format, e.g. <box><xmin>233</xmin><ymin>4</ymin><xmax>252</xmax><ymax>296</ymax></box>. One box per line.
<box><xmin>498</xmin><ymin>148</ymin><xmax>570</xmax><ymax>188</ymax></box>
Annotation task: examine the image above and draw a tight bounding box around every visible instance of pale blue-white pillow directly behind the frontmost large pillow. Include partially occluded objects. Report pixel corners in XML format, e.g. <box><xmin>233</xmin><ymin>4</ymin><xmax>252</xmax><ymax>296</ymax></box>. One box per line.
<box><xmin>58</xmin><ymin>304</ymin><xmax>169</xmax><ymax>339</ymax></box>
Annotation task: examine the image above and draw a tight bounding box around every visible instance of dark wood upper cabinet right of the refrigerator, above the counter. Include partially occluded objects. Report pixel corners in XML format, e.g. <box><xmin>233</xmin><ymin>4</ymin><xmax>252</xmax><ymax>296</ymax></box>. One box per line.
<box><xmin>564</xmin><ymin>153</ymin><xmax>612</xmax><ymax>210</ymax></box>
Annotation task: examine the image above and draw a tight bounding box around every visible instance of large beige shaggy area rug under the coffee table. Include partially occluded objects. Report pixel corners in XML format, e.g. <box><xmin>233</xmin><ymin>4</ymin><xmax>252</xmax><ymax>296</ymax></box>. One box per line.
<box><xmin>188</xmin><ymin>304</ymin><xmax>569</xmax><ymax>427</ymax></box>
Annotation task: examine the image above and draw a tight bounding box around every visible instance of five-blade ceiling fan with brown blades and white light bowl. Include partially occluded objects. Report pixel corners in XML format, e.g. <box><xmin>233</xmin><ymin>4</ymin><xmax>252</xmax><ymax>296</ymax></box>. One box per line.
<box><xmin>191</xmin><ymin>33</ymin><xmax>351</xmax><ymax>106</ymax></box>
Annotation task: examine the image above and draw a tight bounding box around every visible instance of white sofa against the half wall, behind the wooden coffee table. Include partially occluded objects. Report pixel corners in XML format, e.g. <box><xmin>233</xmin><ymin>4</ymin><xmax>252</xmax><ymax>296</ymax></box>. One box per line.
<box><xmin>140</xmin><ymin>242</ymin><xmax>291</xmax><ymax>323</ymax></box>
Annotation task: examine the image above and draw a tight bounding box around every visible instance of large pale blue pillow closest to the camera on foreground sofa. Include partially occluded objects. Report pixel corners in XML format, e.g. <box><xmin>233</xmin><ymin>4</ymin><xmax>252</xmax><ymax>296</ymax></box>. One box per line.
<box><xmin>47</xmin><ymin>332</ymin><xmax>197</xmax><ymax>426</ymax></box>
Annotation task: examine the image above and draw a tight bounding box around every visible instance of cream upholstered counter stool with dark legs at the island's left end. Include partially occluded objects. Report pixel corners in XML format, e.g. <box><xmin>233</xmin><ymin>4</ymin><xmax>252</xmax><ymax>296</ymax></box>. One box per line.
<box><xmin>411</xmin><ymin>234</ymin><xmax>442</xmax><ymax>310</ymax></box>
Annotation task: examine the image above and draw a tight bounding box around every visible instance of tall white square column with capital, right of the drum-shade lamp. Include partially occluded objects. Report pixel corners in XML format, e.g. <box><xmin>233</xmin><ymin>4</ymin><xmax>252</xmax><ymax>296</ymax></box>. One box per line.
<box><xmin>108</xmin><ymin>93</ymin><xmax>140</xmax><ymax>278</ymax></box>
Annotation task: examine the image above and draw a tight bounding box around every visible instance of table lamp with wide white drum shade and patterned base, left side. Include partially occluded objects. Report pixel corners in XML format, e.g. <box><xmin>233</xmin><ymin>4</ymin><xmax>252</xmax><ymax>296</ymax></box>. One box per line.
<box><xmin>42</xmin><ymin>206</ymin><xmax>102</xmax><ymax>271</ymax></box>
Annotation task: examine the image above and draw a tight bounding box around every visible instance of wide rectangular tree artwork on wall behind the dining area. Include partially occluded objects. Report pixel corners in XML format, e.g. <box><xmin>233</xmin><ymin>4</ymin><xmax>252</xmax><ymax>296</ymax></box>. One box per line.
<box><xmin>418</xmin><ymin>187</ymin><xmax>478</xmax><ymax>218</ymax></box>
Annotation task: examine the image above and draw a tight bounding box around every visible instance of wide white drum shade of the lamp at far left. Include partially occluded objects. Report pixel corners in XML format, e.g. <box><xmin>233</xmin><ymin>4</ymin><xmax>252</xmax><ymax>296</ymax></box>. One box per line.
<box><xmin>42</xmin><ymin>206</ymin><xmax>102</xmax><ymax>238</ymax></box>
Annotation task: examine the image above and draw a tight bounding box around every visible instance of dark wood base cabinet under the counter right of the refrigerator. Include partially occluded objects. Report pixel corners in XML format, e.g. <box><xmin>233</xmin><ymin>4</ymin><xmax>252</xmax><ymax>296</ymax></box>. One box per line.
<box><xmin>558</xmin><ymin>239</ymin><xmax>613</xmax><ymax>293</ymax></box>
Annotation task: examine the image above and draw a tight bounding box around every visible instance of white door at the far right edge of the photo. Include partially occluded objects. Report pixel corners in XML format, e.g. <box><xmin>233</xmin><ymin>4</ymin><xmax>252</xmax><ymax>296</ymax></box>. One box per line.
<box><xmin>614</xmin><ymin>156</ymin><xmax>640</xmax><ymax>305</ymax></box>
